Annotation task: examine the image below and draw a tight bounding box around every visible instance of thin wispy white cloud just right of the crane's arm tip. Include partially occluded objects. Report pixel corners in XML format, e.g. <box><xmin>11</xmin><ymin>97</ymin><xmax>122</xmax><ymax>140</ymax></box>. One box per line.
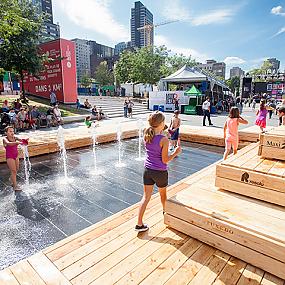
<box><xmin>192</xmin><ymin>9</ymin><xmax>233</xmax><ymax>26</ymax></box>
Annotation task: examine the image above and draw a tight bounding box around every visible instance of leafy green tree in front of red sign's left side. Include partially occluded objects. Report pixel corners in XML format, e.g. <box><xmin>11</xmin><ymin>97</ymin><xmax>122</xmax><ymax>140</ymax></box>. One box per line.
<box><xmin>0</xmin><ymin>0</ymin><xmax>46</xmax><ymax>94</ymax></box>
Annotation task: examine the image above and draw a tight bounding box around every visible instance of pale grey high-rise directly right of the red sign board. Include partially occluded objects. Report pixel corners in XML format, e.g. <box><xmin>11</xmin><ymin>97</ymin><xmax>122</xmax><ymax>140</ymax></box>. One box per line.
<box><xmin>71</xmin><ymin>39</ymin><xmax>91</xmax><ymax>82</ymax></box>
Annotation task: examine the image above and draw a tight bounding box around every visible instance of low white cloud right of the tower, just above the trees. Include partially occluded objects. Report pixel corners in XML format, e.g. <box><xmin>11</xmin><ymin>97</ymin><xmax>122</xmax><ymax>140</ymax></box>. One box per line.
<box><xmin>154</xmin><ymin>35</ymin><xmax>208</xmax><ymax>62</ymax></box>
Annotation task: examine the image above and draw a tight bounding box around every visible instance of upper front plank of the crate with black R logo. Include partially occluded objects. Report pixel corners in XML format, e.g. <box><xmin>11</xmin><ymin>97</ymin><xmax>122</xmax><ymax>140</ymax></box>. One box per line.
<box><xmin>216</xmin><ymin>164</ymin><xmax>285</xmax><ymax>193</ymax></box>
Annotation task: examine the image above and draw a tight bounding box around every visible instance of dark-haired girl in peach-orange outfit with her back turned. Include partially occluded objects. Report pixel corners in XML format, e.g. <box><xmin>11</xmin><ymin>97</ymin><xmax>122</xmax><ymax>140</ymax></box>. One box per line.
<box><xmin>224</xmin><ymin>107</ymin><xmax>248</xmax><ymax>160</ymax></box>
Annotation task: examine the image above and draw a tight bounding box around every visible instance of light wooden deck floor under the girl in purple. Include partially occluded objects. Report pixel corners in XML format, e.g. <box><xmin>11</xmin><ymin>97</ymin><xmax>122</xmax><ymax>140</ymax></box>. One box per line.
<box><xmin>0</xmin><ymin>163</ymin><xmax>285</xmax><ymax>285</ymax></box>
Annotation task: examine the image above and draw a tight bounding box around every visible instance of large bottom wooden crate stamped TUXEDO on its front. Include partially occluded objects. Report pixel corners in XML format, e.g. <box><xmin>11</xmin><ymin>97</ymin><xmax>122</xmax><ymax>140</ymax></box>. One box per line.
<box><xmin>164</xmin><ymin>167</ymin><xmax>285</xmax><ymax>279</ymax></box>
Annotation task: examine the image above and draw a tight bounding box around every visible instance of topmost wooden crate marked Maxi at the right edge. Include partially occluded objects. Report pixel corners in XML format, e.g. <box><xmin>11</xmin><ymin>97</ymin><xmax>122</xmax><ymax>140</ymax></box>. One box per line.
<box><xmin>258</xmin><ymin>126</ymin><xmax>285</xmax><ymax>160</ymax></box>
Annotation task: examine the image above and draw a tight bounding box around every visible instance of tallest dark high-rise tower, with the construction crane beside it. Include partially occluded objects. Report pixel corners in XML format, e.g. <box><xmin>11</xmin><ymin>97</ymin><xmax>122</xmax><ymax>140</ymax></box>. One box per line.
<box><xmin>131</xmin><ymin>1</ymin><xmax>153</xmax><ymax>48</ymax></box>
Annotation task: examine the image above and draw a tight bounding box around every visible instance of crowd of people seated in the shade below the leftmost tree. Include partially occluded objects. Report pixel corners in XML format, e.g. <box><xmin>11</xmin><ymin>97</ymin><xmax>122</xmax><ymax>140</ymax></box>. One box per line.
<box><xmin>0</xmin><ymin>99</ymin><xmax>63</xmax><ymax>131</ymax></box>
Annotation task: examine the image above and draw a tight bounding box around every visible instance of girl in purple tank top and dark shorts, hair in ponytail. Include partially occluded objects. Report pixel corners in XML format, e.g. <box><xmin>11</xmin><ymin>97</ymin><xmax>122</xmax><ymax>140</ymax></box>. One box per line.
<box><xmin>135</xmin><ymin>111</ymin><xmax>181</xmax><ymax>232</ymax></box>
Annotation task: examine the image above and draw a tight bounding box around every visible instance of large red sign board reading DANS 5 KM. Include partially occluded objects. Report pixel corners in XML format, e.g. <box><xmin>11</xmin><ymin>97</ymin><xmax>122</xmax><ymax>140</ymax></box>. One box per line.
<box><xmin>24</xmin><ymin>39</ymin><xmax>77</xmax><ymax>103</ymax></box>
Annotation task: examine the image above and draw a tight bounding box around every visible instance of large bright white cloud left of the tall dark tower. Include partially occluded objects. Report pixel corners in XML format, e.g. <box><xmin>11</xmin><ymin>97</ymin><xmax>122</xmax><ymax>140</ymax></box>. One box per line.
<box><xmin>57</xmin><ymin>0</ymin><xmax>129</xmax><ymax>42</ymax></box>
